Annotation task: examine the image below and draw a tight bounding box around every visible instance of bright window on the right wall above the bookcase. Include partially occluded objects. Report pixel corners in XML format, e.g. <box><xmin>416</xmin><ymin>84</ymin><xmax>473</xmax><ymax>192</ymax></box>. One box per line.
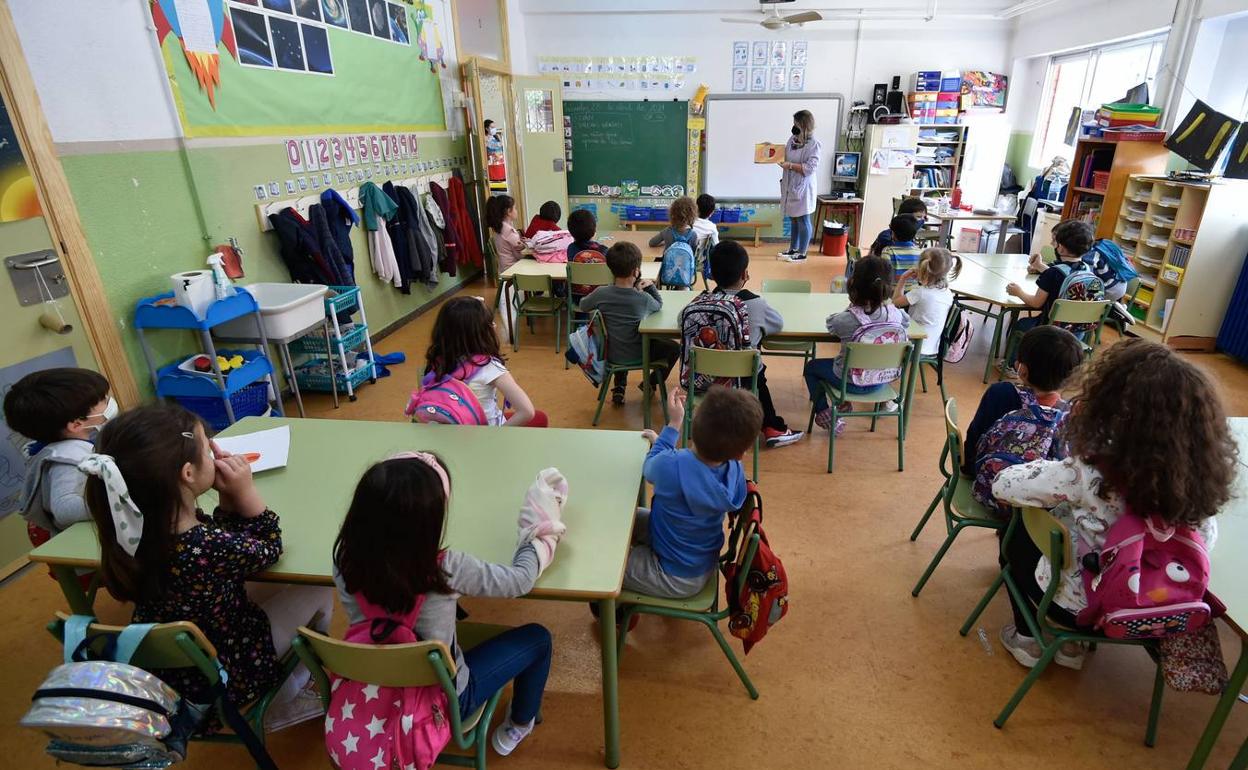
<box><xmin>1030</xmin><ymin>32</ymin><xmax>1166</xmax><ymax>168</ymax></box>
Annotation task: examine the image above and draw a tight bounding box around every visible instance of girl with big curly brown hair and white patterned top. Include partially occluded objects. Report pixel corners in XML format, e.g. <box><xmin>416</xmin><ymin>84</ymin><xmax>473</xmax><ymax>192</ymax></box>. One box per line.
<box><xmin>992</xmin><ymin>339</ymin><xmax>1238</xmax><ymax>669</ymax></box>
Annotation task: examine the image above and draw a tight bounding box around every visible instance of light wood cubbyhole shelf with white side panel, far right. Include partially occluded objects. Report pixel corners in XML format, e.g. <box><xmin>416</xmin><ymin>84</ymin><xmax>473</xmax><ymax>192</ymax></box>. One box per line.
<box><xmin>1118</xmin><ymin>173</ymin><xmax>1248</xmax><ymax>351</ymax></box>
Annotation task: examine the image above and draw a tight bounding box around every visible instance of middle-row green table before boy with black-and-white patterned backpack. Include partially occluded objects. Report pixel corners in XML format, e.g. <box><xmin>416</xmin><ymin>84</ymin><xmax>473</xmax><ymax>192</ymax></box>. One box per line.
<box><xmin>638</xmin><ymin>291</ymin><xmax>927</xmax><ymax>432</ymax></box>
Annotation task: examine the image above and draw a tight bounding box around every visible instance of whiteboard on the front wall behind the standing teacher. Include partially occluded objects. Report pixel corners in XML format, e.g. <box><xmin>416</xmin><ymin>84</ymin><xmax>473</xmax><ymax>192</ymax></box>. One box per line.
<box><xmin>701</xmin><ymin>94</ymin><xmax>841</xmax><ymax>201</ymax></box>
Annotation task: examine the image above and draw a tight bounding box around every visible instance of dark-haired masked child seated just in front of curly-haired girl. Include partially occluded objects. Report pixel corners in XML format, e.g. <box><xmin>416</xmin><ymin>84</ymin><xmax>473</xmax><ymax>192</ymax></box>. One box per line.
<box><xmin>962</xmin><ymin>326</ymin><xmax>1083</xmax><ymax>478</ymax></box>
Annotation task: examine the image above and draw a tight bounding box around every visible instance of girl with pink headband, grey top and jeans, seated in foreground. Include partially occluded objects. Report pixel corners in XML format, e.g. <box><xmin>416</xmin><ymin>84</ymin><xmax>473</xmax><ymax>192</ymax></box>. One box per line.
<box><xmin>327</xmin><ymin>452</ymin><xmax>567</xmax><ymax>756</ymax></box>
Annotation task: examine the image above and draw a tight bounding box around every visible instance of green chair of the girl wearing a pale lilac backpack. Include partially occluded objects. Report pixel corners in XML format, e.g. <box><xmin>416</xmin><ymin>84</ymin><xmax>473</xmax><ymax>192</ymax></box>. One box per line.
<box><xmin>806</xmin><ymin>342</ymin><xmax>915</xmax><ymax>473</ymax></box>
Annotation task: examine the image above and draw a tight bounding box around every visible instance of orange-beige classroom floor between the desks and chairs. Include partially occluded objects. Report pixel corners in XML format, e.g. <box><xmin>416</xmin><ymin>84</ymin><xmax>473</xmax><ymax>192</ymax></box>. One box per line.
<box><xmin>0</xmin><ymin>235</ymin><xmax>1248</xmax><ymax>770</ymax></box>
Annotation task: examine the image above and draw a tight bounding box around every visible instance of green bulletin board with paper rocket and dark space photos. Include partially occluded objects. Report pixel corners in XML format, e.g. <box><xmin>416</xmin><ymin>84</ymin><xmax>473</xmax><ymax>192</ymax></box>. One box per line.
<box><xmin>151</xmin><ymin>0</ymin><xmax>451</xmax><ymax>136</ymax></box>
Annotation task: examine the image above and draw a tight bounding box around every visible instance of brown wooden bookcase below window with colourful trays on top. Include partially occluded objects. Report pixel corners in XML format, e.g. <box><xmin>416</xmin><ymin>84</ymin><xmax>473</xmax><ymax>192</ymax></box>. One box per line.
<box><xmin>1062</xmin><ymin>139</ymin><xmax>1169</xmax><ymax>238</ymax></box>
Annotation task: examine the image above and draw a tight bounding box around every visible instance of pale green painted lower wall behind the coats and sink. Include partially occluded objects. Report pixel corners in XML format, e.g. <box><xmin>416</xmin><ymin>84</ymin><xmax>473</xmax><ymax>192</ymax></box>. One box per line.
<box><xmin>62</xmin><ymin>139</ymin><xmax>472</xmax><ymax>393</ymax></box>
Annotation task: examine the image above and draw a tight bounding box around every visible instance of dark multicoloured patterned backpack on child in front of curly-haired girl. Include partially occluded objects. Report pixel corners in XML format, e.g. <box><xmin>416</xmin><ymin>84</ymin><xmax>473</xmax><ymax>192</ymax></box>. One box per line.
<box><xmin>971</xmin><ymin>388</ymin><xmax>1070</xmax><ymax>518</ymax></box>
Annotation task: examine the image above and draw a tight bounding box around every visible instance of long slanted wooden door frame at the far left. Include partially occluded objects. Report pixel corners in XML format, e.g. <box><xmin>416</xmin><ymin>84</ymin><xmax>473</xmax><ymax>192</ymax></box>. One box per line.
<box><xmin>0</xmin><ymin>0</ymin><xmax>140</xmax><ymax>408</ymax></box>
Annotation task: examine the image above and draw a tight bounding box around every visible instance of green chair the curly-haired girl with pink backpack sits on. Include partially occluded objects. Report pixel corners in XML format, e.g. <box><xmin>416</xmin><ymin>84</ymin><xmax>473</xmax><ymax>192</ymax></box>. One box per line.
<box><xmin>958</xmin><ymin>507</ymin><xmax>1166</xmax><ymax>746</ymax></box>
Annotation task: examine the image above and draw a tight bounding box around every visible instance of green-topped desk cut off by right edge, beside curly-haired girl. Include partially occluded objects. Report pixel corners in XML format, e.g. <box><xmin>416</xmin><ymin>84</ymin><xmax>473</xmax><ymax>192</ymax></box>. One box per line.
<box><xmin>1187</xmin><ymin>417</ymin><xmax>1248</xmax><ymax>770</ymax></box>
